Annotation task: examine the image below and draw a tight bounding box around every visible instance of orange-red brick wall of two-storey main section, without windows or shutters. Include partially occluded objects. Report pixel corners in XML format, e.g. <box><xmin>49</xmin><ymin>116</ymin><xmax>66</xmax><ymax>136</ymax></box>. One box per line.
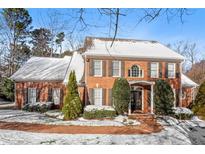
<box><xmin>85</xmin><ymin>57</ymin><xmax>181</xmax><ymax>111</ymax></box>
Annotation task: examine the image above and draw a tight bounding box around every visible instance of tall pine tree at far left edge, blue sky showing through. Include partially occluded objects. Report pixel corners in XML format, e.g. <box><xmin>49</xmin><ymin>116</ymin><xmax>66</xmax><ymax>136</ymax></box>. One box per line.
<box><xmin>0</xmin><ymin>8</ymin><xmax>32</xmax><ymax>76</ymax></box>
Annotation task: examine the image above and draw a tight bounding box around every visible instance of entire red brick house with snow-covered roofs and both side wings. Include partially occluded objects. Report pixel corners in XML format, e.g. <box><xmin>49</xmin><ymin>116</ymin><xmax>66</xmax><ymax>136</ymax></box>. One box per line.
<box><xmin>11</xmin><ymin>37</ymin><xmax>198</xmax><ymax>113</ymax></box>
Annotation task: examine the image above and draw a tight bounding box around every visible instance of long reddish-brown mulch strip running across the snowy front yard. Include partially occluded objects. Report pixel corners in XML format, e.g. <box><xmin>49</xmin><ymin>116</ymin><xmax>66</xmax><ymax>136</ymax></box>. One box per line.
<box><xmin>0</xmin><ymin>121</ymin><xmax>163</xmax><ymax>134</ymax></box>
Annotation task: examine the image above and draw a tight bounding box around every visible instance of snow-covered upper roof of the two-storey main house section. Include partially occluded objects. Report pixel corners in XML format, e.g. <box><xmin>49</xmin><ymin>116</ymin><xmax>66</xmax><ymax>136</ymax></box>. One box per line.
<box><xmin>83</xmin><ymin>37</ymin><xmax>185</xmax><ymax>60</ymax></box>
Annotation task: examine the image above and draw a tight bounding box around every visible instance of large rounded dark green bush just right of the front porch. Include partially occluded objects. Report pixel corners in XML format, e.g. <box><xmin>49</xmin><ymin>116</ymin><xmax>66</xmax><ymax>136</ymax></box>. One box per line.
<box><xmin>154</xmin><ymin>79</ymin><xmax>174</xmax><ymax>115</ymax></box>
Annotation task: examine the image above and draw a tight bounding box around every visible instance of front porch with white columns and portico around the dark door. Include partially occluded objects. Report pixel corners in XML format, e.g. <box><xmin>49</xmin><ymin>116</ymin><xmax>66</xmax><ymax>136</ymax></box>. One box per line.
<box><xmin>128</xmin><ymin>80</ymin><xmax>154</xmax><ymax>115</ymax></box>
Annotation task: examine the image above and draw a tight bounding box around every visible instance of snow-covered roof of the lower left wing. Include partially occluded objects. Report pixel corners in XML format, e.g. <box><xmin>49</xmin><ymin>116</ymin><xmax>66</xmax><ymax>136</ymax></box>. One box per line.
<box><xmin>10</xmin><ymin>52</ymin><xmax>84</xmax><ymax>82</ymax></box>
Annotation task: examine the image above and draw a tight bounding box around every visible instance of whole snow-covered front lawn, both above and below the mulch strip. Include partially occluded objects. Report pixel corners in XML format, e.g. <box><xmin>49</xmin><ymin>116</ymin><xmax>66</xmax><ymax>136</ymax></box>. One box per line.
<box><xmin>0</xmin><ymin>110</ymin><xmax>205</xmax><ymax>144</ymax></box>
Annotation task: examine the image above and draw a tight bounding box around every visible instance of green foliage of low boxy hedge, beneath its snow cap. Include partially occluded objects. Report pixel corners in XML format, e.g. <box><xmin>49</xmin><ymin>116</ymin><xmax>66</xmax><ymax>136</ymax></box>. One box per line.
<box><xmin>83</xmin><ymin>110</ymin><xmax>116</xmax><ymax>119</ymax></box>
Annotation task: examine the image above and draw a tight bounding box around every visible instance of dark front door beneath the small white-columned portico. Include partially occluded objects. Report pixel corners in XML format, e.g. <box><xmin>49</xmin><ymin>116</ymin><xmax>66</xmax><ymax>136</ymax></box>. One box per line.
<box><xmin>131</xmin><ymin>90</ymin><xmax>142</xmax><ymax>112</ymax></box>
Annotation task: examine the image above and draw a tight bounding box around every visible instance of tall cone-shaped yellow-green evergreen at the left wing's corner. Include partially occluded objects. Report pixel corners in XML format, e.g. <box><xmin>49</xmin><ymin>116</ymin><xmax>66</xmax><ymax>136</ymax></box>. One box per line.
<box><xmin>62</xmin><ymin>71</ymin><xmax>82</xmax><ymax>120</ymax></box>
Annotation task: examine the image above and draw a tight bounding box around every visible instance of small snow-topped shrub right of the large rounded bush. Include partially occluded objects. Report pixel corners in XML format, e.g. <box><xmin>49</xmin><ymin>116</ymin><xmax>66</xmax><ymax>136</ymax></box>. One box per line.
<box><xmin>173</xmin><ymin>107</ymin><xmax>193</xmax><ymax>120</ymax></box>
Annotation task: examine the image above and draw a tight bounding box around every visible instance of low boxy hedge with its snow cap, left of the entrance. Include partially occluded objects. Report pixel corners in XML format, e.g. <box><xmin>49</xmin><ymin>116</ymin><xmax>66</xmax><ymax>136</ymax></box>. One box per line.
<box><xmin>83</xmin><ymin>105</ymin><xmax>116</xmax><ymax>119</ymax></box>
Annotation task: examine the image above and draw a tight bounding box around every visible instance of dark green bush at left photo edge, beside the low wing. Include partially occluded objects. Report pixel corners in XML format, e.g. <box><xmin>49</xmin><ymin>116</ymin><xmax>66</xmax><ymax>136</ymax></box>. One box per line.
<box><xmin>0</xmin><ymin>77</ymin><xmax>14</xmax><ymax>101</ymax></box>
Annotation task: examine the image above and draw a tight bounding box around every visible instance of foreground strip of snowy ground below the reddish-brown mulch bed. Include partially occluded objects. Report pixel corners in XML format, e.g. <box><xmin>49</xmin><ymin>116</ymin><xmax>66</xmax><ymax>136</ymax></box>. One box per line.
<box><xmin>0</xmin><ymin>128</ymin><xmax>191</xmax><ymax>145</ymax></box>
